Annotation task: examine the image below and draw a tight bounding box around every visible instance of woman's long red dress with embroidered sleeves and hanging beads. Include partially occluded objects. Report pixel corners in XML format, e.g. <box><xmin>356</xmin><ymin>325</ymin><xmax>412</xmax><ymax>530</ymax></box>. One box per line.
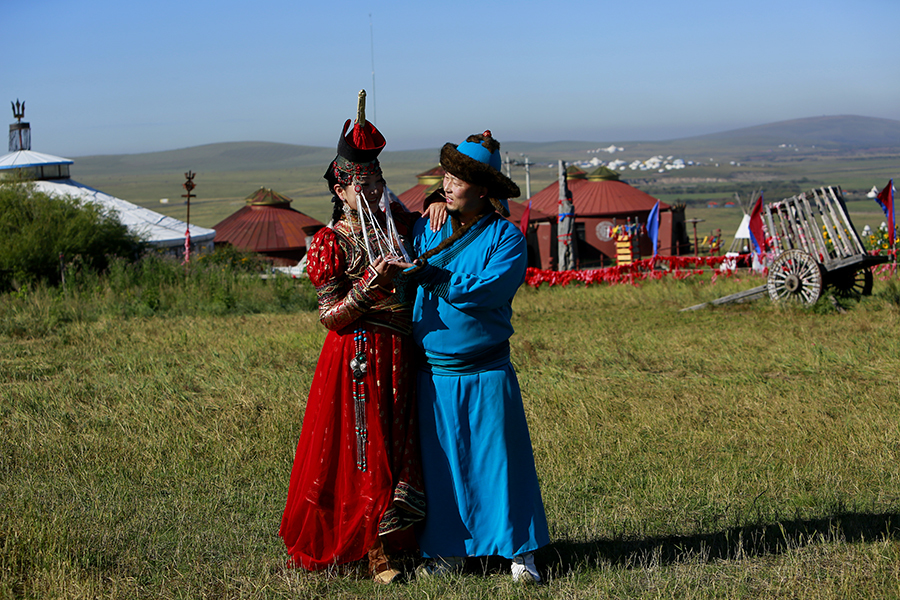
<box><xmin>279</xmin><ymin>209</ymin><xmax>425</xmax><ymax>570</ymax></box>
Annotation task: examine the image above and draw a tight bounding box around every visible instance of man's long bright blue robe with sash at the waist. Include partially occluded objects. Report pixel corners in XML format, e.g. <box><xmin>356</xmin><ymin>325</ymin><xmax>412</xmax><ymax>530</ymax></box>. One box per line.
<box><xmin>413</xmin><ymin>213</ymin><xmax>549</xmax><ymax>558</ymax></box>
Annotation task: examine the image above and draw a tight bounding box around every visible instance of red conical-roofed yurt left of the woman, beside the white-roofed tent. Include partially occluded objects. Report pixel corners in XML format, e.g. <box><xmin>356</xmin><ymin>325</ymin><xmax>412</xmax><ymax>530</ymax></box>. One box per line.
<box><xmin>215</xmin><ymin>188</ymin><xmax>325</xmax><ymax>267</ymax></box>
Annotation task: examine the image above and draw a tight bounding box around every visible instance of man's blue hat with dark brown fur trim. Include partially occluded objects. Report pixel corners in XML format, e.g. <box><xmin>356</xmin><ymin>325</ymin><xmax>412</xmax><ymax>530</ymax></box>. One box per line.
<box><xmin>441</xmin><ymin>130</ymin><xmax>521</xmax><ymax>217</ymax></box>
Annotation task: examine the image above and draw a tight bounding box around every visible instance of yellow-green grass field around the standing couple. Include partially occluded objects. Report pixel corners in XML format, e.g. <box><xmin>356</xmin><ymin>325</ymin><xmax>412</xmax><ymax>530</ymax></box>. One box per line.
<box><xmin>0</xmin><ymin>275</ymin><xmax>900</xmax><ymax>599</ymax></box>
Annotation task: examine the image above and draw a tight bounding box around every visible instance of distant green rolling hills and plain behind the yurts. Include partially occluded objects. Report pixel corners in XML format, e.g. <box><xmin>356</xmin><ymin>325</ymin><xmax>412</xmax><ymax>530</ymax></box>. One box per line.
<box><xmin>65</xmin><ymin>115</ymin><xmax>900</xmax><ymax>227</ymax></box>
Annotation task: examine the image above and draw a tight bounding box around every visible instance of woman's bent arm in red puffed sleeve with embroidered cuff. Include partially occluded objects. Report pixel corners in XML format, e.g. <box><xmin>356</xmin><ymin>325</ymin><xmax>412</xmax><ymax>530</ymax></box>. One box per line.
<box><xmin>306</xmin><ymin>228</ymin><xmax>391</xmax><ymax>331</ymax></box>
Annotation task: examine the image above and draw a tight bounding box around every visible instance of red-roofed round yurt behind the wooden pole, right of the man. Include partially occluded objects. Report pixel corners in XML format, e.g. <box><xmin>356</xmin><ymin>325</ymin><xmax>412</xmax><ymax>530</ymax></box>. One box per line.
<box><xmin>531</xmin><ymin>167</ymin><xmax>689</xmax><ymax>268</ymax></box>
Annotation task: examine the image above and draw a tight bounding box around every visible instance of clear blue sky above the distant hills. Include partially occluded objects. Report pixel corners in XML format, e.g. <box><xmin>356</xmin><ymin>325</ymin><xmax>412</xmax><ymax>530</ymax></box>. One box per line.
<box><xmin>7</xmin><ymin>0</ymin><xmax>900</xmax><ymax>157</ymax></box>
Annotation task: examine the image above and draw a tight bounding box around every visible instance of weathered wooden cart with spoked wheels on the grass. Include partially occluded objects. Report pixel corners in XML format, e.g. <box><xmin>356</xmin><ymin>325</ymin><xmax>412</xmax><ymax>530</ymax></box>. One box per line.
<box><xmin>684</xmin><ymin>186</ymin><xmax>888</xmax><ymax>310</ymax></box>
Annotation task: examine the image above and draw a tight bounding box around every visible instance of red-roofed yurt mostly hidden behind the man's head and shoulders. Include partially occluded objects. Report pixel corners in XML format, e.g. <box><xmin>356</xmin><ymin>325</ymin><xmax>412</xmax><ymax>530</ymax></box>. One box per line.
<box><xmin>397</xmin><ymin>165</ymin><xmax>556</xmax><ymax>269</ymax></box>
